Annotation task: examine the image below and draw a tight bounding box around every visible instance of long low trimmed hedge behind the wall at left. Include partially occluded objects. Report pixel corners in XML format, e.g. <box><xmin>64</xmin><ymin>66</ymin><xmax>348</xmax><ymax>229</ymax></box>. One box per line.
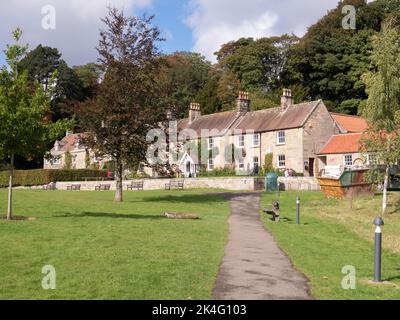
<box><xmin>0</xmin><ymin>169</ymin><xmax>107</xmax><ymax>188</ymax></box>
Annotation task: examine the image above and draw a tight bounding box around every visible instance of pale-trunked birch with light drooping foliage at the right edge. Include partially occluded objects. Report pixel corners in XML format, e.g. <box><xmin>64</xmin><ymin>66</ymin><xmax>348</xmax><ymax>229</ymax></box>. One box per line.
<box><xmin>362</xmin><ymin>19</ymin><xmax>400</xmax><ymax>214</ymax></box>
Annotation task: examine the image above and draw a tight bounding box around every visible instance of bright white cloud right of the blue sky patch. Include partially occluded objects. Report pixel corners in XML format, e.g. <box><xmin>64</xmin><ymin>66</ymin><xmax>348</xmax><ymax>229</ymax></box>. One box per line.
<box><xmin>186</xmin><ymin>0</ymin><xmax>338</xmax><ymax>61</ymax></box>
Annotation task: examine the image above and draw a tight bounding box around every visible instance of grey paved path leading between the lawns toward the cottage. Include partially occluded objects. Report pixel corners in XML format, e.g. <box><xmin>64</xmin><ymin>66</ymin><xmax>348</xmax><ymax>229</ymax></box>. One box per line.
<box><xmin>214</xmin><ymin>193</ymin><xmax>311</xmax><ymax>300</ymax></box>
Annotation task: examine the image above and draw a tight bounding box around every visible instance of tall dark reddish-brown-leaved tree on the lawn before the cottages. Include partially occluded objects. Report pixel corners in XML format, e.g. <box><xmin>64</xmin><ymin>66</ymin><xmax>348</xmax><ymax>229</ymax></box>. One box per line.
<box><xmin>78</xmin><ymin>8</ymin><xmax>169</xmax><ymax>202</ymax></box>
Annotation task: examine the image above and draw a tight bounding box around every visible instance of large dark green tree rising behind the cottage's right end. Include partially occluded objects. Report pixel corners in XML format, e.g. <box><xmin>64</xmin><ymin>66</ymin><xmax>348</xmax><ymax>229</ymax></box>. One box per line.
<box><xmin>282</xmin><ymin>0</ymin><xmax>400</xmax><ymax>114</ymax></box>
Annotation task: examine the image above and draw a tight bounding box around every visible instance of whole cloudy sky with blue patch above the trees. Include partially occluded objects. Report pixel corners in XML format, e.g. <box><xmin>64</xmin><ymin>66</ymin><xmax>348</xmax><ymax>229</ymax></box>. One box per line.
<box><xmin>0</xmin><ymin>0</ymin><xmax>346</xmax><ymax>66</ymax></box>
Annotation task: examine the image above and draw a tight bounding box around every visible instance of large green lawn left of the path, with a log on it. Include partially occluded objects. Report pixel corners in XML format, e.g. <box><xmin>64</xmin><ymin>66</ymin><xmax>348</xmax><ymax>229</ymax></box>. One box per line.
<box><xmin>0</xmin><ymin>189</ymin><xmax>229</xmax><ymax>299</ymax></box>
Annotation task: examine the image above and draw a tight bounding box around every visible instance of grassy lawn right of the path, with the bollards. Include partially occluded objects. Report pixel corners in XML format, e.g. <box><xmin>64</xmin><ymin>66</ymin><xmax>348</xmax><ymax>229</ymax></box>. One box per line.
<box><xmin>262</xmin><ymin>192</ymin><xmax>400</xmax><ymax>299</ymax></box>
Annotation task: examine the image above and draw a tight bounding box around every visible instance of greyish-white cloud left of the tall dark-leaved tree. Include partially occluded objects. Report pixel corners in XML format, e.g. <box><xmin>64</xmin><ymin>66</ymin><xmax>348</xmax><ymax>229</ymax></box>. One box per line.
<box><xmin>0</xmin><ymin>0</ymin><xmax>152</xmax><ymax>65</ymax></box>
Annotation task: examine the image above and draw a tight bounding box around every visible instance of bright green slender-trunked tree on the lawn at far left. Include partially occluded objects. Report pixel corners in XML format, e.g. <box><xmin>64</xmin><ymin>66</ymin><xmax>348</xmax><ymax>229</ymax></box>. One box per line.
<box><xmin>0</xmin><ymin>29</ymin><xmax>70</xmax><ymax>220</ymax></box>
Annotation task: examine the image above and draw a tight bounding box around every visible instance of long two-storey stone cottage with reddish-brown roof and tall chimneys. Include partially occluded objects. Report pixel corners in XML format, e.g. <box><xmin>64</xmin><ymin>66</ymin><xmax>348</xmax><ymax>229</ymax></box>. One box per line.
<box><xmin>178</xmin><ymin>89</ymin><xmax>346</xmax><ymax>176</ymax></box>
